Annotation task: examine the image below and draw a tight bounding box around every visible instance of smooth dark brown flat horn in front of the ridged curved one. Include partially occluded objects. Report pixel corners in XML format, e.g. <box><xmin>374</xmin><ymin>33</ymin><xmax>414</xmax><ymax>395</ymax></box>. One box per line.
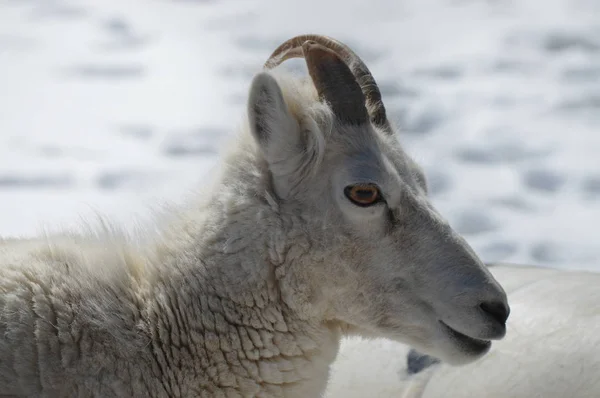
<box><xmin>302</xmin><ymin>40</ymin><xmax>369</xmax><ymax>125</ymax></box>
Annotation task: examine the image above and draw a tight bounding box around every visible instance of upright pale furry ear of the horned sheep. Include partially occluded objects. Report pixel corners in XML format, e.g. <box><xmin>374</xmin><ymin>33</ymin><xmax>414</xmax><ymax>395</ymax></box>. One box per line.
<box><xmin>248</xmin><ymin>72</ymin><xmax>304</xmax><ymax>198</ymax></box>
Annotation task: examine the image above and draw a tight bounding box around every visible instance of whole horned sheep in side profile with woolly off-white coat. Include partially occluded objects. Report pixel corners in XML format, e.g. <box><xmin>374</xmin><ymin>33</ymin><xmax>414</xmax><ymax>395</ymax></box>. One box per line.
<box><xmin>0</xmin><ymin>35</ymin><xmax>509</xmax><ymax>398</ymax></box>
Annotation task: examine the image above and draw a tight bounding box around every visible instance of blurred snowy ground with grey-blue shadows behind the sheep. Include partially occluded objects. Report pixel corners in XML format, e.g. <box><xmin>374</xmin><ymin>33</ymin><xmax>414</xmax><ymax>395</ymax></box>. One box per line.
<box><xmin>0</xmin><ymin>0</ymin><xmax>600</xmax><ymax>271</ymax></box>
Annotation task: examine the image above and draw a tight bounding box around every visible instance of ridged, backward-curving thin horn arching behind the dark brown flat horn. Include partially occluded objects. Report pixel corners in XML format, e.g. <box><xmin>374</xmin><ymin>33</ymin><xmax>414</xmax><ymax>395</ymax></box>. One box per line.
<box><xmin>264</xmin><ymin>34</ymin><xmax>392</xmax><ymax>133</ymax></box>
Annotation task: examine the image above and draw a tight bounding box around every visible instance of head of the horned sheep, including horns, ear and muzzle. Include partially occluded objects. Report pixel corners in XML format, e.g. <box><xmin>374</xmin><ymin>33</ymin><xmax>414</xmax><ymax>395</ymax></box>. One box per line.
<box><xmin>248</xmin><ymin>35</ymin><xmax>509</xmax><ymax>364</ymax></box>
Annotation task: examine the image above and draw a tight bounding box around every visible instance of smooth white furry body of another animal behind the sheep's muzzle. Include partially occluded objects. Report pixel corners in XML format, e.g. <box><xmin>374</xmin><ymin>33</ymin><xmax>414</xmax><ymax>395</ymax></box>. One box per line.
<box><xmin>327</xmin><ymin>265</ymin><xmax>600</xmax><ymax>398</ymax></box>
